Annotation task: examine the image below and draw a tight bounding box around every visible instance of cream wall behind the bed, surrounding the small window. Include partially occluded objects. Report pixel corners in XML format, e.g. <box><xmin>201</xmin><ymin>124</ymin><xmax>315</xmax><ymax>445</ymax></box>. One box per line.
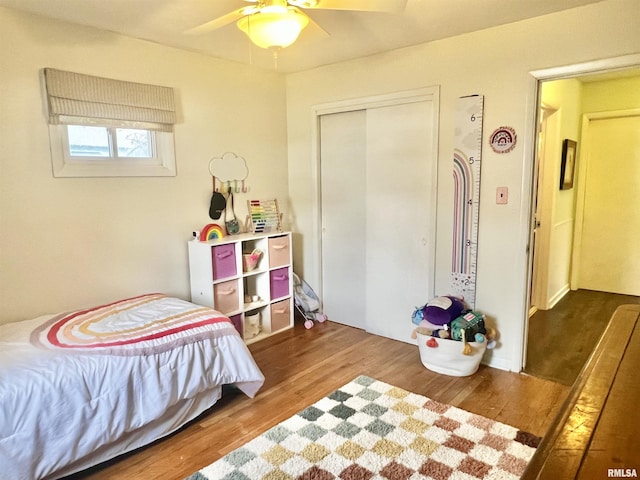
<box><xmin>0</xmin><ymin>8</ymin><xmax>288</xmax><ymax>323</ymax></box>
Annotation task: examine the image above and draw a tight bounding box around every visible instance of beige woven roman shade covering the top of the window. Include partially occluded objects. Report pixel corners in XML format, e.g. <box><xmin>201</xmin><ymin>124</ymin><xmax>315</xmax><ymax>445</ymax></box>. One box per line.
<box><xmin>44</xmin><ymin>68</ymin><xmax>176</xmax><ymax>132</ymax></box>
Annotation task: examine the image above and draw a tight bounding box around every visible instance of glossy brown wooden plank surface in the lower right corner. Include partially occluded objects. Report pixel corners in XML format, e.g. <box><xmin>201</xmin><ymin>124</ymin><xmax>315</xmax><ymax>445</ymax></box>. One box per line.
<box><xmin>522</xmin><ymin>305</ymin><xmax>640</xmax><ymax>480</ymax></box>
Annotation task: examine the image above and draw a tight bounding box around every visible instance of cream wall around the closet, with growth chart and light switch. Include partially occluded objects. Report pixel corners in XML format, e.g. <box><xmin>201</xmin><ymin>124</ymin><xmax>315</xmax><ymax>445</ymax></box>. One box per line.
<box><xmin>287</xmin><ymin>0</ymin><xmax>640</xmax><ymax>370</ymax></box>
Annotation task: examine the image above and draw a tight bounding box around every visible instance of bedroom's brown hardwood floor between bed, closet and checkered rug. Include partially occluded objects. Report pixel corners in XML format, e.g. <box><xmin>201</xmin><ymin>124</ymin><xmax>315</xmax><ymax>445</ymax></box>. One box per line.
<box><xmin>69</xmin><ymin>322</ymin><xmax>569</xmax><ymax>480</ymax></box>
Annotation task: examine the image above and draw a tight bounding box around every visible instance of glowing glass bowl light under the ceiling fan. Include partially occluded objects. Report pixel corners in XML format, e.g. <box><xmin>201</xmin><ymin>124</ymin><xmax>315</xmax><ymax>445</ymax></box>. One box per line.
<box><xmin>237</xmin><ymin>7</ymin><xmax>309</xmax><ymax>48</ymax></box>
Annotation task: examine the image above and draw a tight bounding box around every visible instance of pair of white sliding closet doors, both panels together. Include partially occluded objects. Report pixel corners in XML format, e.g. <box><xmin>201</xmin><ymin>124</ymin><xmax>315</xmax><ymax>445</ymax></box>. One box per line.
<box><xmin>320</xmin><ymin>90</ymin><xmax>437</xmax><ymax>342</ymax></box>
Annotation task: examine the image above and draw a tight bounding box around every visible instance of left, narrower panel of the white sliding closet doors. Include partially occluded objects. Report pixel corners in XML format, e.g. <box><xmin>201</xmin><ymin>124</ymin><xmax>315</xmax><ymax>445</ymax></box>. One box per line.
<box><xmin>320</xmin><ymin>110</ymin><xmax>366</xmax><ymax>328</ymax></box>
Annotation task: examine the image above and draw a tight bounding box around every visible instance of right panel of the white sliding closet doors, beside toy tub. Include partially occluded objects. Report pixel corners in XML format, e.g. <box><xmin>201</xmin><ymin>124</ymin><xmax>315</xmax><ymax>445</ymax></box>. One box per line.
<box><xmin>366</xmin><ymin>102</ymin><xmax>435</xmax><ymax>342</ymax></box>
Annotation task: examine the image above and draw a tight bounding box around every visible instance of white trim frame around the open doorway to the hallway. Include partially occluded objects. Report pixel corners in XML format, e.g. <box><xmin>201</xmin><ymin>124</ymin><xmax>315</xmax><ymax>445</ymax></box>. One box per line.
<box><xmin>511</xmin><ymin>54</ymin><xmax>640</xmax><ymax>372</ymax></box>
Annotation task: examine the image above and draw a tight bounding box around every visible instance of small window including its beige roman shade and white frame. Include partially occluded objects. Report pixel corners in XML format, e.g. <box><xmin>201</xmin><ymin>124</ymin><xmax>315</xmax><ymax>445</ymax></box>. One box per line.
<box><xmin>44</xmin><ymin>69</ymin><xmax>176</xmax><ymax>177</ymax></box>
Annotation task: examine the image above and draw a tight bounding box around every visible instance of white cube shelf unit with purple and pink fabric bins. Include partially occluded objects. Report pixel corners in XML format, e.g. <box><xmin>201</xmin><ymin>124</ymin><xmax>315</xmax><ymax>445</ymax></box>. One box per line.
<box><xmin>188</xmin><ymin>232</ymin><xmax>293</xmax><ymax>343</ymax></box>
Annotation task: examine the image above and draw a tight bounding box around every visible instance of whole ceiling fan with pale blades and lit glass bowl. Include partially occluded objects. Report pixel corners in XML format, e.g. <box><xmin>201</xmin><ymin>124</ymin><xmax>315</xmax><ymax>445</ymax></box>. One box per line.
<box><xmin>187</xmin><ymin>0</ymin><xmax>407</xmax><ymax>49</ymax></box>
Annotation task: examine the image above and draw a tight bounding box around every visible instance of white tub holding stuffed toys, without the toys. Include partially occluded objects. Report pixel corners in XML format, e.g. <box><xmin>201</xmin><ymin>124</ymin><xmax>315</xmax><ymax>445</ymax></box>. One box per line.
<box><xmin>416</xmin><ymin>332</ymin><xmax>487</xmax><ymax>377</ymax></box>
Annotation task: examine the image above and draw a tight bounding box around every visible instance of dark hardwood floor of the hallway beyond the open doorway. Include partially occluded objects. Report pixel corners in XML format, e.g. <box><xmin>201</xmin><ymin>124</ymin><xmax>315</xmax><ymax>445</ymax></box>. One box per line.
<box><xmin>524</xmin><ymin>290</ymin><xmax>640</xmax><ymax>386</ymax></box>
